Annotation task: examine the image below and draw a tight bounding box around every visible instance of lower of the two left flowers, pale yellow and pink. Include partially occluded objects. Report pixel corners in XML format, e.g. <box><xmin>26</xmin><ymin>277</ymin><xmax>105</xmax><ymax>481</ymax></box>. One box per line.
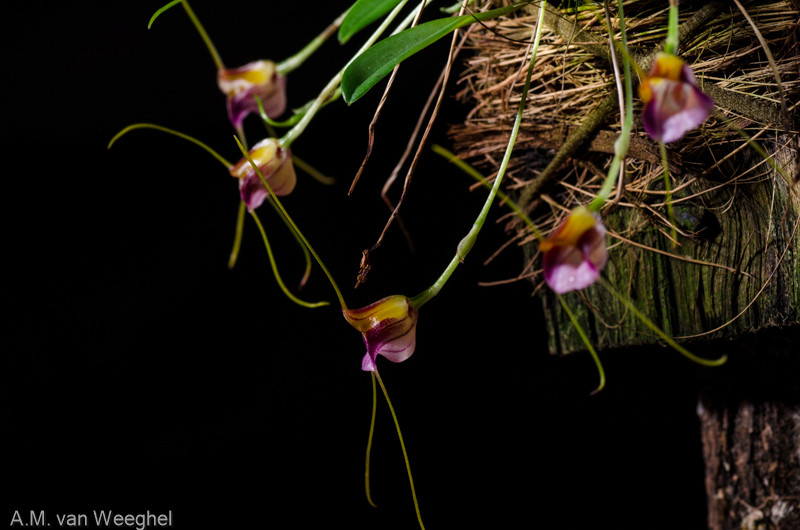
<box><xmin>230</xmin><ymin>138</ymin><xmax>297</xmax><ymax>211</ymax></box>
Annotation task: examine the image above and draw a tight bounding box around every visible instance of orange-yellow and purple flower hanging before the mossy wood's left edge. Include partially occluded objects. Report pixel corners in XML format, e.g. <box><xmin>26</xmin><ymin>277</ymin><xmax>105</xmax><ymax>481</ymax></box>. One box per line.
<box><xmin>539</xmin><ymin>206</ymin><xmax>608</xmax><ymax>294</ymax></box>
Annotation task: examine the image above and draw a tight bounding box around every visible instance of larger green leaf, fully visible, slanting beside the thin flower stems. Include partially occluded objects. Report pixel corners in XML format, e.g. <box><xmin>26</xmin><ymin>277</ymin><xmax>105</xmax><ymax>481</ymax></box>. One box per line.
<box><xmin>342</xmin><ymin>2</ymin><xmax>528</xmax><ymax>105</ymax></box>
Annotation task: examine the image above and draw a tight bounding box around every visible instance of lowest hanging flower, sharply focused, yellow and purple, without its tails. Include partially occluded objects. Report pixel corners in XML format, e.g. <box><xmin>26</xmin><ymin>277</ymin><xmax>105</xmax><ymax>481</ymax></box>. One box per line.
<box><xmin>342</xmin><ymin>295</ymin><xmax>418</xmax><ymax>372</ymax></box>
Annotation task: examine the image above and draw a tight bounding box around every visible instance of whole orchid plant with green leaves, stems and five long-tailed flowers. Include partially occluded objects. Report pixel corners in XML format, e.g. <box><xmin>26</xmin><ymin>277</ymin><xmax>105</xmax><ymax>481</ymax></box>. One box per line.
<box><xmin>109</xmin><ymin>0</ymin><xmax>744</xmax><ymax>529</ymax></box>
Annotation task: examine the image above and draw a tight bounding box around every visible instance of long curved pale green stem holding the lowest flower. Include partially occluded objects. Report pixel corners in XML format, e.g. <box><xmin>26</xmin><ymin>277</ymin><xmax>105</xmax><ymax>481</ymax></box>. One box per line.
<box><xmin>410</xmin><ymin>1</ymin><xmax>546</xmax><ymax>308</ymax></box>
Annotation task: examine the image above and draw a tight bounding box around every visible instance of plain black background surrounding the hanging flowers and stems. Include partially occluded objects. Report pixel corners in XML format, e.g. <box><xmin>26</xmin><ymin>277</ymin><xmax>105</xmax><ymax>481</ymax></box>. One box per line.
<box><xmin>0</xmin><ymin>0</ymin><xmax>705</xmax><ymax>529</ymax></box>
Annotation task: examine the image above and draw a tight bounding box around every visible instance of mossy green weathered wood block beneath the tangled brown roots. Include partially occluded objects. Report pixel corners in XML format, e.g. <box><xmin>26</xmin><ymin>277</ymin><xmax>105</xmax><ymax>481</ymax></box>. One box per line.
<box><xmin>544</xmin><ymin>155</ymin><xmax>800</xmax><ymax>353</ymax></box>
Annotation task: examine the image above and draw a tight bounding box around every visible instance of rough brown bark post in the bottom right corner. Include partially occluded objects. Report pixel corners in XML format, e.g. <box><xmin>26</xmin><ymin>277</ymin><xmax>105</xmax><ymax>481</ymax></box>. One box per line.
<box><xmin>697</xmin><ymin>333</ymin><xmax>800</xmax><ymax>530</ymax></box>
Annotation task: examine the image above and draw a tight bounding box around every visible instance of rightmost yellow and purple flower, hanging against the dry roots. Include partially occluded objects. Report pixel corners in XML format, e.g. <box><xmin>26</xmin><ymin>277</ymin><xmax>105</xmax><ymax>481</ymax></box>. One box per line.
<box><xmin>639</xmin><ymin>53</ymin><xmax>714</xmax><ymax>143</ymax></box>
